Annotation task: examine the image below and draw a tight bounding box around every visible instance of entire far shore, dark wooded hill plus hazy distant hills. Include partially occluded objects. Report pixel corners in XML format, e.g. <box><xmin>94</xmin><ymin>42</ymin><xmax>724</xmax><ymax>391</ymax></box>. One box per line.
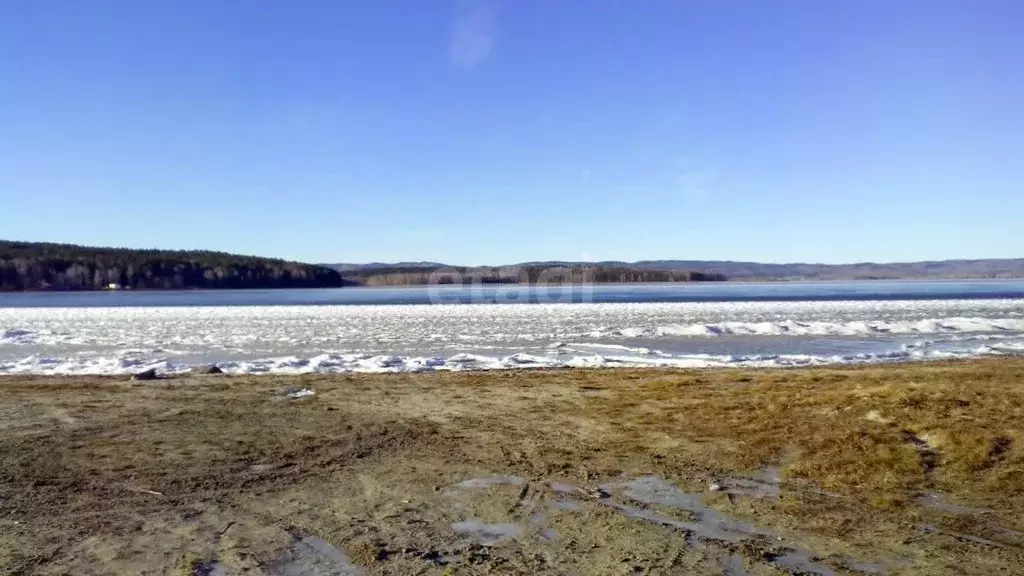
<box><xmin>0</xmin><ymin>240</ymin><xmax>1024</xmax><ymax>292</ymax></box>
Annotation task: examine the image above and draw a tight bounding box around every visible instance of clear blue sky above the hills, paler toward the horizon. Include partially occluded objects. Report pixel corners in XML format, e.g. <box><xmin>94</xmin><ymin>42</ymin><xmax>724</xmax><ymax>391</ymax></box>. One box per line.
<box><xmin>0</xmin><ymin>0</ymin><xmax>1024</xmax><ymax>264</ymax></box>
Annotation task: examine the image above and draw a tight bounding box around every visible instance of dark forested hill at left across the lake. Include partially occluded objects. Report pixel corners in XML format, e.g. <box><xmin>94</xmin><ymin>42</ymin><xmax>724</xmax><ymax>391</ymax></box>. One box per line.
<box><xmin>0</xmin><ymin>241</ymin><xmax>345</xmax><ymax>291</ymax></box>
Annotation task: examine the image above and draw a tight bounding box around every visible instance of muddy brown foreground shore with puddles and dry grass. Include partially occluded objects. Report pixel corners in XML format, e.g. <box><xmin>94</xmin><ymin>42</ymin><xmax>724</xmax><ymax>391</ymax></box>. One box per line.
<box><xmin>0</xmin><ymin>359</ymin><xmax>1024</xmax><ymax>575</ymax></box>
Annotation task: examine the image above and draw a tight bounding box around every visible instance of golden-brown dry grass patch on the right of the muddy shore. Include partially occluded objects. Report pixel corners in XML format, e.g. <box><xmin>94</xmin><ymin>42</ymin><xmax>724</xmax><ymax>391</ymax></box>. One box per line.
<box><xmin>588</xmin><ymin>361</ymin><xmax>1024</xmax><ymax>502</ymax></box>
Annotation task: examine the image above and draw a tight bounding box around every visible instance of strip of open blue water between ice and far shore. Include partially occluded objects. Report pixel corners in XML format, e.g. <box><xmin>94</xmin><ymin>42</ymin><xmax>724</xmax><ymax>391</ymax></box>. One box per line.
<box><xmin>0</xmin><ymin>280</ymin><xmax>1024</xmax><ymax>308</ymax></box>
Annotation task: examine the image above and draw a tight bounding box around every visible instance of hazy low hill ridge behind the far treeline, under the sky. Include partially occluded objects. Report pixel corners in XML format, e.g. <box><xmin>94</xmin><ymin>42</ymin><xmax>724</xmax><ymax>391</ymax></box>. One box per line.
<box><xmin>324</xmin><ymin>258</ymin><xmax>1024</xmax><ymax>281</ymax></box>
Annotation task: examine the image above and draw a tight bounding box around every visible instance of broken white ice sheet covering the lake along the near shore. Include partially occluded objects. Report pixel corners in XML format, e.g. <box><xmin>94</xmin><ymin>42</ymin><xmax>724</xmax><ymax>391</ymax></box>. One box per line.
<box><xmin>0</xmin><ymin>299</ymin><xmax>1024</xmax><ymax>374</ymax></box>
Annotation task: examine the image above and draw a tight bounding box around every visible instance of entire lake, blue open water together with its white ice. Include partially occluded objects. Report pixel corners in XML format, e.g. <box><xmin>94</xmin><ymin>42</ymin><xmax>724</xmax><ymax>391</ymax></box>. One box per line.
<box><xmin>0</xmin><ymin>281</ymin><xmax>1024</xmax><ymax>374</ymax></box>
